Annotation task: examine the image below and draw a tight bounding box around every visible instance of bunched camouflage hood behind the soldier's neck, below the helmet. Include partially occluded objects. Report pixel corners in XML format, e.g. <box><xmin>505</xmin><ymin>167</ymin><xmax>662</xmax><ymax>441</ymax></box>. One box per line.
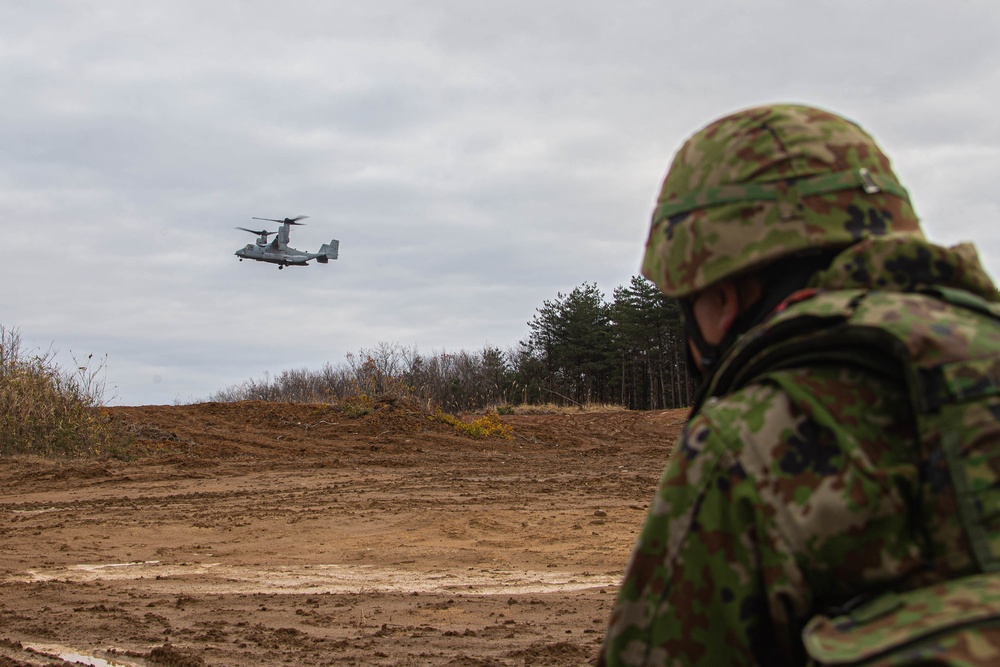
<box><xmin>809</xmin><ymin>234</ymin><xmax>1000</xmax><ymax>301</ymax></box>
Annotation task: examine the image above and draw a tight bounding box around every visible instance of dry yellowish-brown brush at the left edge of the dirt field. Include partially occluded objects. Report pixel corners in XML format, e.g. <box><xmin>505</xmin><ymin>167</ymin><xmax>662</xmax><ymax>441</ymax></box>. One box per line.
<box><xmin>0</xmin><ymin>325</ymin><xmax>131</xmax><ymax>456</ymax></box>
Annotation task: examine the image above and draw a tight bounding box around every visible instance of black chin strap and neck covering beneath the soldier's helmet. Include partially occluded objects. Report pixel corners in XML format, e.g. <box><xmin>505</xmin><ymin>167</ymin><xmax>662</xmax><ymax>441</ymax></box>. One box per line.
<box><xmin>680</xmin><ymin>250</ymin><xmax>837</xmax><ymax>396</ymax></box>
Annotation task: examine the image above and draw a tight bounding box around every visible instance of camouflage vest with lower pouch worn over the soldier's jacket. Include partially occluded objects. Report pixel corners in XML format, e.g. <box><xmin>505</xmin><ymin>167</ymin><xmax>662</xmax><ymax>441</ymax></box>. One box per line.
<box><xmin>694</xmin><ymin>287</ymin><xmax>1000</xmax><ymax>665</ymax></box>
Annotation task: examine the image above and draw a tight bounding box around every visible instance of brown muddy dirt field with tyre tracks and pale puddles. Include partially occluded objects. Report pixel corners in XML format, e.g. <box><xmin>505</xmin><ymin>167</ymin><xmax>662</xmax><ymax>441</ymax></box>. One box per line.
<box><xmin>0</xmin><ymin>403</ymin><xmax>685</xmax><ymax>667</ymax></box>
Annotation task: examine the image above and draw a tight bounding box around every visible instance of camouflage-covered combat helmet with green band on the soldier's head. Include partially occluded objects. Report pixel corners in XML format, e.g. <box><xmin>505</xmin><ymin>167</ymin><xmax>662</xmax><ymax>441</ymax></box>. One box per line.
<box><xmin>642</xmin><ymin>104</ymin><xmax>923</xmax><ymax>297</ymax></box>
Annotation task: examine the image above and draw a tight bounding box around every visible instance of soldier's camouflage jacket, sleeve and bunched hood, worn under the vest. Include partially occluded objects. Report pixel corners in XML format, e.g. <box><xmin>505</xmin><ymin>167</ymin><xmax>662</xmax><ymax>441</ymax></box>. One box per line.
<box><xmin>600</xmin><ymin>236</ymin><xmax>1000</xmax><ymax>665</ymax></box>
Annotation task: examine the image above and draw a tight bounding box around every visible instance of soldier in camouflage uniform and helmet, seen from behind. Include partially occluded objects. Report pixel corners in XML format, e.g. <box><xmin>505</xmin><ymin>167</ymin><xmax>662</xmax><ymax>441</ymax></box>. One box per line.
<box><xmin>600</xmin><ymin>105</ymin><xmax>1000</xmax><ymax>665</ymax></box>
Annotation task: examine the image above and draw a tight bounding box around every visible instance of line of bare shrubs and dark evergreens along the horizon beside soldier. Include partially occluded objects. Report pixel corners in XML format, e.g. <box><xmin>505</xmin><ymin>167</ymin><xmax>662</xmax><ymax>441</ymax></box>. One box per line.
<box><xmin>209</xmin><ymin>276</ymin><xmax>695</xmax><ymax>412</ymax></box>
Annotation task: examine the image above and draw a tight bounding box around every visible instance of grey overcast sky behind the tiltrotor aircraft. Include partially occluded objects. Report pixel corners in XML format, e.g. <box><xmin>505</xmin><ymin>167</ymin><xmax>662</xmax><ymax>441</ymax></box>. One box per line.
<box><xmin>0</xmin><ymin>0</ymin><xmax>1000</xmax><ymax>405</ymax></box>
